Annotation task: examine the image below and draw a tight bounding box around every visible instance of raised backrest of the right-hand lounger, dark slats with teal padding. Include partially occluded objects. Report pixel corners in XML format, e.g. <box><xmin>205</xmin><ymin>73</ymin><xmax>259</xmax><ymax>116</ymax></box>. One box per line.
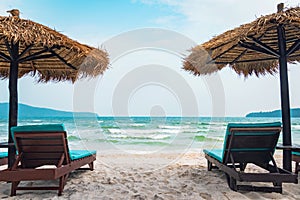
<box><xmin>223</xmin><ymin>122</ymin><xmax>281</xmax><ymax>164</ymax></box>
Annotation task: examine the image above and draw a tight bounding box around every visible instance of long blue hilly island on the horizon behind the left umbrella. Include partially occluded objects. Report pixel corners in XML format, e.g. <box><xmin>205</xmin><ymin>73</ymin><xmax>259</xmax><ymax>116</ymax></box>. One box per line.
<box><xmin>0</xmin><ymin>103</ymin><xmax>98</xmax><ymax>119</ymax></box>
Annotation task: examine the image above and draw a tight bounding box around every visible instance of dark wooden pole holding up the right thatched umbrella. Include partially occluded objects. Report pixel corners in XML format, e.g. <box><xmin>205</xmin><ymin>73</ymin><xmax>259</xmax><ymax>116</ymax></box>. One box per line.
<box><xmin>277</xmin><ymin>25</ymin><xmax>292</xmax><ymax>171</ymax></box>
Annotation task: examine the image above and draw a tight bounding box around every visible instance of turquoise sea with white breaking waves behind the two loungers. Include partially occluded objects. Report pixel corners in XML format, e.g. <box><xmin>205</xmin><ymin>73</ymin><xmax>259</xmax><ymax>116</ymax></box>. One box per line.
<box><xmin>0</xmin><ymin>117</ymin><xmax>300</xmax><ymax>154</ymax></box>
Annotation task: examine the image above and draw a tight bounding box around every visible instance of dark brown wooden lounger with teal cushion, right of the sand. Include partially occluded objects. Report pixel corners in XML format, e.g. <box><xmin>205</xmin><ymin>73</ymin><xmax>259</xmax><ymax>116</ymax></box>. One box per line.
<box><xmin>204</xmin><ymin>122</ymin><xmax>298</xmax><ymax>193</ymax></box>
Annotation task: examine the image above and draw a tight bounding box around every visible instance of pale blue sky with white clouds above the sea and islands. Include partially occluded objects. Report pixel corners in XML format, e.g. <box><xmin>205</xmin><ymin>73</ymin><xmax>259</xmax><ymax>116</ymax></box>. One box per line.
<box><xmin>0</xmin><ymin>0</ymin><xmax>300</xmax><ymax>116</ymax></box>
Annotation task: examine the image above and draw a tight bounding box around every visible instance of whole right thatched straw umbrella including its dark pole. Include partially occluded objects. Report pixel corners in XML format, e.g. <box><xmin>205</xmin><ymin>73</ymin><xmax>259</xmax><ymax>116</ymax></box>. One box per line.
<box><xmin>184</xmin><ymin>4</ymin><xmax>300</xmax><ymax>170</ymax></box>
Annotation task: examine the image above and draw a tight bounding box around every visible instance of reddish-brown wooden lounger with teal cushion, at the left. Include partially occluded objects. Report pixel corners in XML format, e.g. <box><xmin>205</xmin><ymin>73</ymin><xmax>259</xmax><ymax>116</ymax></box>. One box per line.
<box><xmin>0</xmin><ymin>124</ymin><xmax>96</xmax><ymax>196</ymax></box>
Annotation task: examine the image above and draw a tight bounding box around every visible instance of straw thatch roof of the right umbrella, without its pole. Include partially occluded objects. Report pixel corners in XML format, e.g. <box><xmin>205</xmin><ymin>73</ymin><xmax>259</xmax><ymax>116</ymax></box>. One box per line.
<box><xmin>184</xmin><ymin>4</ymin><xmax>300</xmax><ymax>76</ymax></box>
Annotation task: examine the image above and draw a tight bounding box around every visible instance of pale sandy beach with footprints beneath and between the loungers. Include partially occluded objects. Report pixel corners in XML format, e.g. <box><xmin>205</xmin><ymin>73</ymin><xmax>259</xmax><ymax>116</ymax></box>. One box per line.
<box><xmin>0</xmin><ymin>152</ymin><xmax>300</xmax><ymax>200</ymax></box>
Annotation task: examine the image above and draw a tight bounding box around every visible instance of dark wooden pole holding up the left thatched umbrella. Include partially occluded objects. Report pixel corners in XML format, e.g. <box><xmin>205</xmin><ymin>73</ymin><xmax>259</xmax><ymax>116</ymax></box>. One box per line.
<box><xmin>8</xmin><ymin>42</ymin><xmax>19</xmax><ymax>168</ymax></box>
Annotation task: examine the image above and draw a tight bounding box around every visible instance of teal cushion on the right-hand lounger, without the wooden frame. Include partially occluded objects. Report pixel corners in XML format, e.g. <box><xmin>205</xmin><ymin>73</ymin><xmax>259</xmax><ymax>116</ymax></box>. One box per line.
<box><xmin>203</xmin><ymin>122</ymin><xmax>281</xmax><ymax>162</ymax></box>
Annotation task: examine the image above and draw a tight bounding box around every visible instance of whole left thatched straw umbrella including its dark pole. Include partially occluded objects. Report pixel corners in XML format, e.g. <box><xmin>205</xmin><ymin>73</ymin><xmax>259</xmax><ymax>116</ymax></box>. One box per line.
<box><xmin>0</xmin><ymin>9</ymin><xmax>109</xmax><ymax>166</ymax></box>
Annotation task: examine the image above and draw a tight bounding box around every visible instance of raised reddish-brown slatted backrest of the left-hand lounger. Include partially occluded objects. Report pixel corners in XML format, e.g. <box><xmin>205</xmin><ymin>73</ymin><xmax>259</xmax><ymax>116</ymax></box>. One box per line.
<box><xmin>11</xmin><ymin>124</ymin><xmax>70</xmax><ymax>168</ymax></box>
